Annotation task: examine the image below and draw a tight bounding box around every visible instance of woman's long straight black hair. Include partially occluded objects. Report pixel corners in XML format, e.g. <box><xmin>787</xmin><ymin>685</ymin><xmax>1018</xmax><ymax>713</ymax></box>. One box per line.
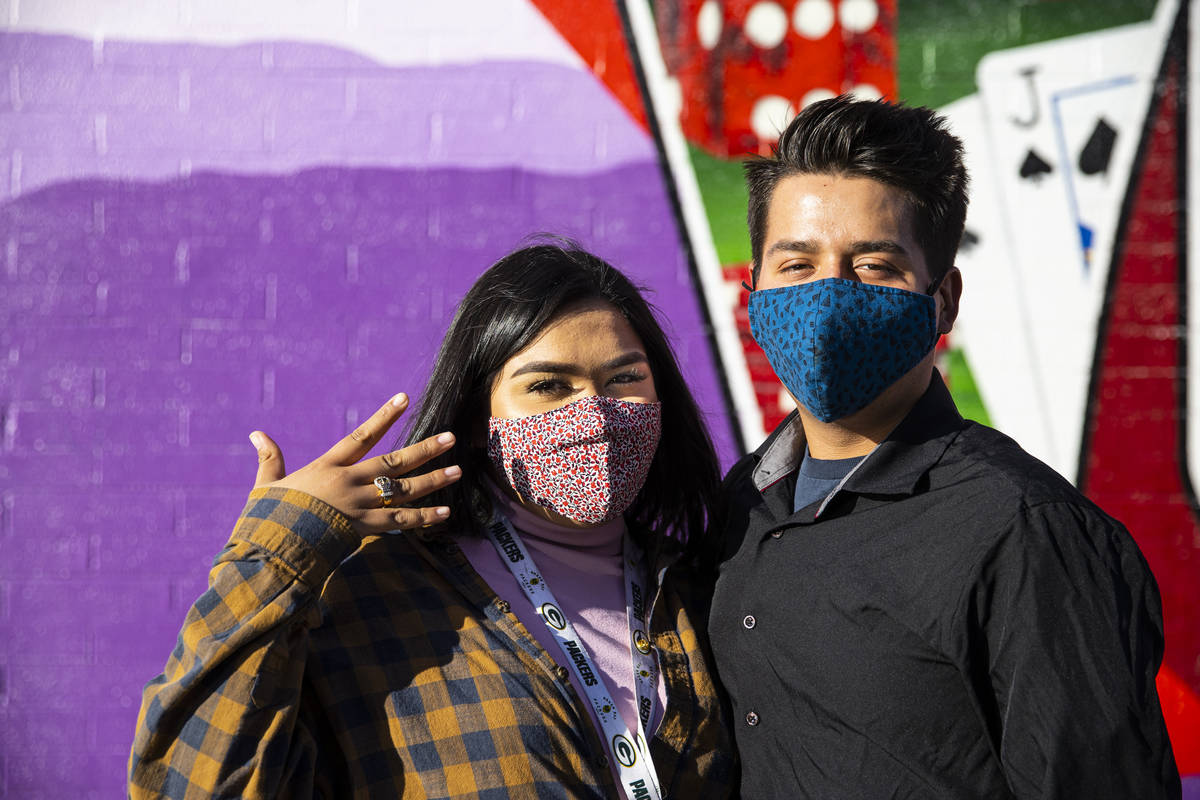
<box><xmin>406</xmin><ymin>237</ymin><xmax>719</xmax><ymax>563</ymax></box>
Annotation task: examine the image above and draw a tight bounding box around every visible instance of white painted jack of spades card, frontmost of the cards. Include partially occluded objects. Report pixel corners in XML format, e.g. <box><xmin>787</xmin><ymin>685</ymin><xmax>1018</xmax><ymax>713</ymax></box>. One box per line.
<box><xmin>977</xmin><ymin>0</ymin><xmax>1175</xmax><ymax>477</ymax></box>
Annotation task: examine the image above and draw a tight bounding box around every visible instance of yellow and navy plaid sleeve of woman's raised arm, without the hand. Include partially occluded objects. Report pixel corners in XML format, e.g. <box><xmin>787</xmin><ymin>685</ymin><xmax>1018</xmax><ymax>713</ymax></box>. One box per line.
<box><xmin>130</xmin><ymin>488</ymin><xmax>358</xmax><ymax>799</ymax></box>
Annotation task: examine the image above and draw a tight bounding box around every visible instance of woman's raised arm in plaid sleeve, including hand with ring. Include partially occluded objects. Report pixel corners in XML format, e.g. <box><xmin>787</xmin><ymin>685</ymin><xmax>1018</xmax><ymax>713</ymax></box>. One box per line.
<box><xmin>128</xmin><ymin>396</ymin><xmax>457</xmax><ymax>798</ymax></box>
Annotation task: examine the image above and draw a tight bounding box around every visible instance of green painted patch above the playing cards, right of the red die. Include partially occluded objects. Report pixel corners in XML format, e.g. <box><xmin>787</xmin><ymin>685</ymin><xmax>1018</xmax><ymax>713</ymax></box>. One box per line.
<box><xmin>896</xmin><ymin>0</ymin><xmax>1156</xmax><ymax>108</ymax></box>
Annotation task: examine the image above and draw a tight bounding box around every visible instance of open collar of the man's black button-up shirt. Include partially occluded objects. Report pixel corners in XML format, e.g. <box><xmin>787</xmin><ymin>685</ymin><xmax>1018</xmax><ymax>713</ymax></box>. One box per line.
<box><xmin>752</xmin><ymin>369</ymin><xmax>964</xmax><ymax>494</ymax></box>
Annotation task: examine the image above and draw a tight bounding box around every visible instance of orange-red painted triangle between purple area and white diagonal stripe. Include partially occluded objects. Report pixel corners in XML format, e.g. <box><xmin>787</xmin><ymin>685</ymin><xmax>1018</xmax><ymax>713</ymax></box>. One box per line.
<box><xmin>532</xmin><ymin>0</ymin><xmax>650</xmax><ymax>131</ymax></box>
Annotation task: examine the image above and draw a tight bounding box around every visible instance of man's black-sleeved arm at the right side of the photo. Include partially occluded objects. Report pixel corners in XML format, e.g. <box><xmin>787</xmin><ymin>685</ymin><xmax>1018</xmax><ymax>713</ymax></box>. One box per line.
<box><xmin>961</xmin><ymin>503</ymin><xmax>1181</xmax><ymax>800</ymax></box>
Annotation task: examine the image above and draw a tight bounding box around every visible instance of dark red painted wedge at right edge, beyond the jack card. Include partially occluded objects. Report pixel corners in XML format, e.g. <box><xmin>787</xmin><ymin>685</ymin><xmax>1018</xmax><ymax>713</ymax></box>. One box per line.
<box><xmin>1081</xmin><ymin>48</ymin><xmax>1200</xmax><ymax>774</ymax></box>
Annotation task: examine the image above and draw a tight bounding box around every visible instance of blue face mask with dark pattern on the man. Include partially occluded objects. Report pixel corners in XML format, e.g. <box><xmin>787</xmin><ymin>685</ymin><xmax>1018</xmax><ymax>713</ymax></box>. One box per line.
<box><xmin>750</xmin><ymin>278</ymin><xmax>937</xmax><ymax>422</ymax></box>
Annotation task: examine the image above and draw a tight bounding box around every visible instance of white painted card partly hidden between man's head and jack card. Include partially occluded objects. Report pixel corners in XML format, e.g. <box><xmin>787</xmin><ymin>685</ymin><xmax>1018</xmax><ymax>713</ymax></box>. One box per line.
<box><xmin>938</xmin><ymin>95</ymin><xmax>1055</xmax><ymax>462</ymax></box>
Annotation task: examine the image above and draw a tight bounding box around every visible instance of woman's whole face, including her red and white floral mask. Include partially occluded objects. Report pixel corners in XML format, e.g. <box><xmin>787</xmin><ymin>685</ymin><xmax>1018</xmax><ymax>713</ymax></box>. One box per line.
<box><xmin>487</xmin><ymin>302</ymin><xmax>662</xmax><ymax>525</ymax></box>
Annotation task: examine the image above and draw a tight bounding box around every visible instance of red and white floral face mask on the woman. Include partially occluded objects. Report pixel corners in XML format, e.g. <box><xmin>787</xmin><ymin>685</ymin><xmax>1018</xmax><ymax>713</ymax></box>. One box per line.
<box><xmin>487</xmin><ymin>396</ymin><xmax>662</xmax><ymax>524</ymax></box>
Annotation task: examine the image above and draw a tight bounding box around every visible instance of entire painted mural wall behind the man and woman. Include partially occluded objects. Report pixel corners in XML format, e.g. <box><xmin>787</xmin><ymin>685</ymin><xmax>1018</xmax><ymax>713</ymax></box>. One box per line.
<box><xmin>0</xmin><ymin>0</ymin><xmax>1200</xmax><ymax>798</ymax></box>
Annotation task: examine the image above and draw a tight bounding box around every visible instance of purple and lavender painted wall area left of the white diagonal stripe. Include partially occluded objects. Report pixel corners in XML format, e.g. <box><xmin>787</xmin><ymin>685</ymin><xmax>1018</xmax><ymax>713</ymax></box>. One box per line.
<box><xmin>0</xmin><ymin>32</ymin><xmax>734</xmax><ymax>798</ymax></box>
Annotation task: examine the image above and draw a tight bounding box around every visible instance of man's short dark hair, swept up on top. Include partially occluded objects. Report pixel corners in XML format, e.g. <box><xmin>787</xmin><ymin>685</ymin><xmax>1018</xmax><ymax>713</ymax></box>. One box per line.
<box><xmin>744</xmin><ymin>95</ymin><xmax>967</xmax><ymax>285</ymax></box>
